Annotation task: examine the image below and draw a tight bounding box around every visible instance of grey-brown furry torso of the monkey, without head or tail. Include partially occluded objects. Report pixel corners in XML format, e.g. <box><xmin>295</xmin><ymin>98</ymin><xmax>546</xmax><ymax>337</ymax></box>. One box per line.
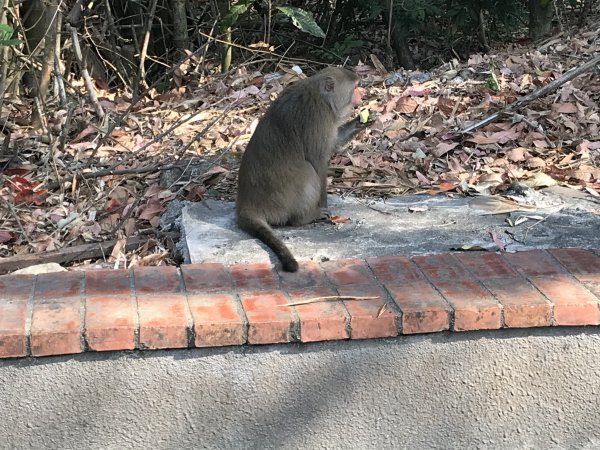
<box><xmin>236</xmin><ymin>77</ymin><xmax>339</xmax><ymax>225</ymax></box>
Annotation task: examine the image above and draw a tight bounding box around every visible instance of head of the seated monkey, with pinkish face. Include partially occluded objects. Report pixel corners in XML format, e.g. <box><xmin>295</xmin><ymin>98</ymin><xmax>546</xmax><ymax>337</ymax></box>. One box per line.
<box><xmin>313</xmin><ymin>67</ymin><xmax>362</xmax><ymax>118</ymax></box>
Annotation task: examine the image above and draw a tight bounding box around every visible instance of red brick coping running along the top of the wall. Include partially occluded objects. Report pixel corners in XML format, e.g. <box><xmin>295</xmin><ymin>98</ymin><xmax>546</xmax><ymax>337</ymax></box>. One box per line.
<box><xmin>0</xmin><ymin>249</ymin><xmax>600</xmax><ymax>358</ymax></box>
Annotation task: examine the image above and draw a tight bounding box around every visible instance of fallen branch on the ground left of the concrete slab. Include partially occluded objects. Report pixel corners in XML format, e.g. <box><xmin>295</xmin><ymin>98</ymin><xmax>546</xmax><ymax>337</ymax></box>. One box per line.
<box><xmin>0</xmin><ymin>232</ymin><xmax>179</xmax><ymax>275</ymax></box>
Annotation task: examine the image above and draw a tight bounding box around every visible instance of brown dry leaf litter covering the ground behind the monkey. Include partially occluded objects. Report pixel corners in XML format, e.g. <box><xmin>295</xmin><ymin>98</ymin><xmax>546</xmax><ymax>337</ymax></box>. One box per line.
<box><xmin>0</xmin><ymin>17</ymin><xmax>600</xmax><ymax>268</ymax></box>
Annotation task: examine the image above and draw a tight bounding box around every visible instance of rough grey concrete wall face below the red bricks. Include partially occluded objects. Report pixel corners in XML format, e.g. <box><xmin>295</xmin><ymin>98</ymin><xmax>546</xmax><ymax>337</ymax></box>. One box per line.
<box><xmin>0</xmin><ymin>328</ymin><xmax>600</xmax><ymax>450</ymax></box>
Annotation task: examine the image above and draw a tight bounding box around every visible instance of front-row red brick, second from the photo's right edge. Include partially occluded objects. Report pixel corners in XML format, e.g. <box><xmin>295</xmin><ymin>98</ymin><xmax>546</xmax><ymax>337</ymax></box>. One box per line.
<box><xmin>483</xmin><ymin>277</ymin><xmax>552</xmax><ymax>328</ymax></box>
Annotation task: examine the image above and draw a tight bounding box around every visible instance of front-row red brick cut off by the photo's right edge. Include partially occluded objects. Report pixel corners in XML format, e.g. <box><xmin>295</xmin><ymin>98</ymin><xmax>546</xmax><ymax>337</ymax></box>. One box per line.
<box><xmin>531</xmin><ymin>275</ymin><xmax>600</xmax><ymax>325</ymax></box>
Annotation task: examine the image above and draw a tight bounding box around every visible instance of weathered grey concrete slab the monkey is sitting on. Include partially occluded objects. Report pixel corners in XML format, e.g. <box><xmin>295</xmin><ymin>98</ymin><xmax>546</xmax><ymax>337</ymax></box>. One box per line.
<box><xmin>172</xmin><ymin>187</ymin><xmax>600</xmax><ymax>264</ymax></box>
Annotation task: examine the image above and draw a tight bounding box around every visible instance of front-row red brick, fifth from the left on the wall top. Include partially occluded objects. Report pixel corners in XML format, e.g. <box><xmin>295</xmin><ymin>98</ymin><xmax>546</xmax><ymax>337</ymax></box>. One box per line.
<box><xmin>188</xmin><ymin>294</ymin><xmax>246</xmax><ymax>347</ymax></box>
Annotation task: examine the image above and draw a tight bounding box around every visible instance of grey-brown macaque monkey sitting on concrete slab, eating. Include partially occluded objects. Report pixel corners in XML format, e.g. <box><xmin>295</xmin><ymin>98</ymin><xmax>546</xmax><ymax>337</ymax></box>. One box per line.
<box><xmin>236</xmin><ymin>67</ymin><xmax>361</xmax><ymax>272</ymax></box>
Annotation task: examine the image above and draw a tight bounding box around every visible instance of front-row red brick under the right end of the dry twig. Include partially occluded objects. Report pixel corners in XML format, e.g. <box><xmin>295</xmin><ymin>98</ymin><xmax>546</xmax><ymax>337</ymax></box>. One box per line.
<box><xmin>338</xmin><ymin>286</ymin><xmax>398</xmax><ymax>339</ymax></box>
